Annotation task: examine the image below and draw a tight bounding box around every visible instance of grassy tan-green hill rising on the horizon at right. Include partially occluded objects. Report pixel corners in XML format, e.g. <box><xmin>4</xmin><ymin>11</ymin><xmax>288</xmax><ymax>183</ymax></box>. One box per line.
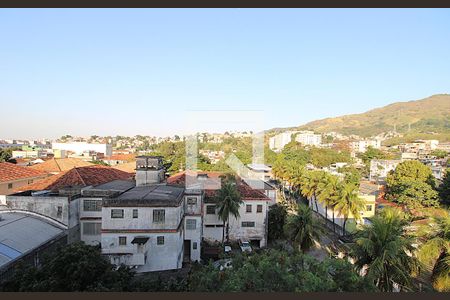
<box><xmin>270</xmin><ymin>94</ymin><xmax>450</xmax><ymax>137</ymax></box>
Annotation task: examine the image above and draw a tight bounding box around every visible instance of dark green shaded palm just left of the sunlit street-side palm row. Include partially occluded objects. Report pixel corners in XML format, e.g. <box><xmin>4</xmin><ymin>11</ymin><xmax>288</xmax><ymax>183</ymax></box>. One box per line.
<box><xmin>285</xmin><ymin>204</ymin><xmax>322</xmax><ymax>251</ymax></box>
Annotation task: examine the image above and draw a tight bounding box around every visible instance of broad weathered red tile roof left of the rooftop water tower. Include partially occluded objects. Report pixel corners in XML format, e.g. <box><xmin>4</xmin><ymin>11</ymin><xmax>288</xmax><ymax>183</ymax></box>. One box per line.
<box><xmin>16</xmin><ymin>165</ymin><xmax>133</xmax><ymax>192</ymax></box>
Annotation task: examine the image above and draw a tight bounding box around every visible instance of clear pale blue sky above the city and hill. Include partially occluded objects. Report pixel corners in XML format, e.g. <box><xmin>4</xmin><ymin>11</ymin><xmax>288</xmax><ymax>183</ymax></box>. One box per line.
<box><xmin>0</xmin><ymin>9</ymin><xmax>450</xmax><ymax>138</ymax></box>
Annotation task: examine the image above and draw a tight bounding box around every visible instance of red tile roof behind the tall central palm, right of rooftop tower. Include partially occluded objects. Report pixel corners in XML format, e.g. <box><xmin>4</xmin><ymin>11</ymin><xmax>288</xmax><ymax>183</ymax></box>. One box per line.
<box><xmin>167</xmin><ymin>171</ymin><xmax>270</xmax><ymax>201</ymax></box>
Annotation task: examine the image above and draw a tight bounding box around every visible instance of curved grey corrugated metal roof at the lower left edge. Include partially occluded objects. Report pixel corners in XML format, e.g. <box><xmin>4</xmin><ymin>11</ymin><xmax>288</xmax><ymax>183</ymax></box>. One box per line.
<box><xmin>0</xmin><ymin>212</ymin><xmax>64</xmax><ymax>267</ymax></box>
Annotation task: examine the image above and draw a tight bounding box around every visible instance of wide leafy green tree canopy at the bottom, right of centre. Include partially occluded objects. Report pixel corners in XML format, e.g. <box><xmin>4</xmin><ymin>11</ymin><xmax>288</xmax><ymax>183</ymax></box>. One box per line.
<box><xmin>188</xmin><ymin>250</ymin><xmax>376</xmax><ymax>292</ymax></box>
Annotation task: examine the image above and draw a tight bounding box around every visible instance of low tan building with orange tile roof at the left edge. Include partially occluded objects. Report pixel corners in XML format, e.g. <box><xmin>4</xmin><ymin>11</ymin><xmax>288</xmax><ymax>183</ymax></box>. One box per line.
<box><xmin>0</xmin><ymin>162</ymin><xmax>49</xmax><ymax>195</ymax></box>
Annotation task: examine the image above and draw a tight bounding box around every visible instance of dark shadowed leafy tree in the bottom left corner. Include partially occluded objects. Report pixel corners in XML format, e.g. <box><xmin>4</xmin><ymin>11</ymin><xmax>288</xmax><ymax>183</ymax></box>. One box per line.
<box><xmin>3</xmin><ymin>242</ymin><xmax>132</xmax><ymax>292</ymax></box>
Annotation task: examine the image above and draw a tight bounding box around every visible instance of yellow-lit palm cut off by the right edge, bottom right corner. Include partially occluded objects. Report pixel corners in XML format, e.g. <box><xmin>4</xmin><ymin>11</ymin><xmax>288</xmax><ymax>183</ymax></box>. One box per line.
<box><xmin>418</xmin><ymin>216</ymin><xmax>450</xmax><ymax>292</ymax></box>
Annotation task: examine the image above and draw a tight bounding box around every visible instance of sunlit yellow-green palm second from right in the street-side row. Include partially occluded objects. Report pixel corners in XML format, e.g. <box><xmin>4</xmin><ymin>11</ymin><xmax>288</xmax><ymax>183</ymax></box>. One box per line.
<box><xmin>318</xmin><ymin>174</ymin><xmax>341</xmax><ymax>232</ymax></box>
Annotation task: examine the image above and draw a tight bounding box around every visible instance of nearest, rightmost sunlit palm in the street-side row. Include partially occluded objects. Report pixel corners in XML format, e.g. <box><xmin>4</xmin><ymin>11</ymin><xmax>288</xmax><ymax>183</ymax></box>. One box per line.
<box><xmin>335</xmin><ymin>183</ymin><xmax>365</xmax><ymax>235</ymax></box>
